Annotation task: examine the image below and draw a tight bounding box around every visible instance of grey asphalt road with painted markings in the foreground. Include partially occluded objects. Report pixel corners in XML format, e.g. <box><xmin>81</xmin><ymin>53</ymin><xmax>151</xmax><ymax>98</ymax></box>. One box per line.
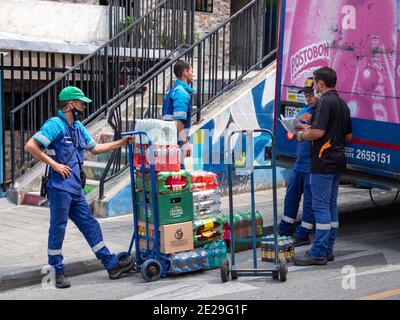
<box><xmin>0</xmin><ymin>207</ymin><xmax>400</xmax><ymax>300</ymax></box>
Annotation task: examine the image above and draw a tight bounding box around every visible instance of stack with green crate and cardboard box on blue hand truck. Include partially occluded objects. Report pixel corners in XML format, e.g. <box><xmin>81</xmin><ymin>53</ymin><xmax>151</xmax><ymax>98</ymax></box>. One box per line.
<box><xmin>134</xmin><ymin>135</ymin><xmax>194</xmax><ymax>254</ymax></box>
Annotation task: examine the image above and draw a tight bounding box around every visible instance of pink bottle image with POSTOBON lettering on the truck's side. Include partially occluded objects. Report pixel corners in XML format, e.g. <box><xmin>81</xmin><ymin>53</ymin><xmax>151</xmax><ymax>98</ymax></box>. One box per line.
<box><xmin>282</xmin><ymin>0</ymin><xmax>342</xmax><ymax>92</ymax></box>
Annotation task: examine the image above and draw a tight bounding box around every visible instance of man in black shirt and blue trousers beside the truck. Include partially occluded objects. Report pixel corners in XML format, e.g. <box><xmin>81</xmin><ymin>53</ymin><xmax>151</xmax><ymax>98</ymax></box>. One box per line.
<box><xmin>294</xmin><ymin>67</ymin><xmax>352</xmax><ymax>266</ymax></box>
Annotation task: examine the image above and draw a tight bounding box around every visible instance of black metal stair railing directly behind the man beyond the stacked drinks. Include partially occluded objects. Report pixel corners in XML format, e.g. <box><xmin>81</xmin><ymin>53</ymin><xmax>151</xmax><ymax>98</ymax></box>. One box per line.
<box><xmin>99</xmin><ymin>0</ymin><xmax>278</xmax><ymax>199</ymax></box>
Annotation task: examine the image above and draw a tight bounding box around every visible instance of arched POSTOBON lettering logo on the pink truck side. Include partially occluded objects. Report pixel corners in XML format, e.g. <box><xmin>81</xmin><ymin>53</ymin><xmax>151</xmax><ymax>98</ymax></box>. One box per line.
<box><xmin>290</xmin><ymin>41</ymin><xmax>331</xmax><ymax>82</ymax></box>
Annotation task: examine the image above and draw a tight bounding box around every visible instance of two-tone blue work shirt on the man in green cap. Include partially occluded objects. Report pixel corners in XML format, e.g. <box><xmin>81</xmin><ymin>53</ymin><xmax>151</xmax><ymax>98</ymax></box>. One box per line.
<box><xmin>32</xmin><ymin>111</ymin><xmax>96</xmax><ymax>195</ymax></box>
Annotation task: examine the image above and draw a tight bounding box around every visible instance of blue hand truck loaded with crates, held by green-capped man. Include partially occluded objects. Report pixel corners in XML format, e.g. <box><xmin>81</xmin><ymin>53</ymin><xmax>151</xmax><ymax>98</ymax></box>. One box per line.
<box><xmin>117</xmin><ymin>131</ymin><xmax>170</xmax><ymax>282</ymax></box>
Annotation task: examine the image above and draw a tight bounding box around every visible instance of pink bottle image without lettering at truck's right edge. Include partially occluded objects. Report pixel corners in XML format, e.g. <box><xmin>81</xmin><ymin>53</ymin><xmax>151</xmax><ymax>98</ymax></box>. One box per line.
<box><xmin>333</xmin><ymin>0</ymin><xmax>399</xmax><ymax>123</ymax></box>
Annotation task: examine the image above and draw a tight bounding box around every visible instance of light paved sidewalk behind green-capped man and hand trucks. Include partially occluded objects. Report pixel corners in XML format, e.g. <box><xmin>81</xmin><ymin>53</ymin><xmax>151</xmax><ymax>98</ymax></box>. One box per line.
<box><xmin>0</xmin><ymin>186</ymin><xmax>399</xmax><ymax>291</ymax></box>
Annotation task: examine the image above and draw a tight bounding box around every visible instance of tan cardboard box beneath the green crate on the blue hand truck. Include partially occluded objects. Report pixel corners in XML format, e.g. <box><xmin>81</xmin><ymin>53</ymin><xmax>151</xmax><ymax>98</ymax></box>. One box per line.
<box><xmin>139</xmin><ymin>221</ymin><xmax>194</xmax><ymax>254</ymax></box>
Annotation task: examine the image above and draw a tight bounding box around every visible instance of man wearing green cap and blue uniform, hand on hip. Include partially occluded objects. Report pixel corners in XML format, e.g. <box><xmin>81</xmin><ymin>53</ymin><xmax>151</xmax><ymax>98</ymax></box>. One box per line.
<box><xmin>25</xmin><ymin>86</ymin><xmax>134</xmax><ymax>288</ymax></box>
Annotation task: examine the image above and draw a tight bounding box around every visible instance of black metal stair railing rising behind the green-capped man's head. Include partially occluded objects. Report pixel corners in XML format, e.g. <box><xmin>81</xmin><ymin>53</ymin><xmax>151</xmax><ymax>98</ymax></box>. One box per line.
<box><xmin>10</xmin><ymin>0</ymin><xmax>194</xmax><ymax>187</ymax></box>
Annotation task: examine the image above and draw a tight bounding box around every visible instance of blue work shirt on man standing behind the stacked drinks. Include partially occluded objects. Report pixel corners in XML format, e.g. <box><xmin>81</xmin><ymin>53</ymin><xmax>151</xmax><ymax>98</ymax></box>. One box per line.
<box><xmin>172</xmin><ymin>80</ymin><xmax>194</xmax><ymax>129</ymax></box>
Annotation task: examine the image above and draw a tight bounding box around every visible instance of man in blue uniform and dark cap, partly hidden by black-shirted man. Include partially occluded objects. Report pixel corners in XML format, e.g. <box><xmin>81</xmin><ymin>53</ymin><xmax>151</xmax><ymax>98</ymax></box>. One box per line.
<box><xmin>278</xmin><ymin>77</ymin><xmax>318</xmax><ymax>247</ymax></box>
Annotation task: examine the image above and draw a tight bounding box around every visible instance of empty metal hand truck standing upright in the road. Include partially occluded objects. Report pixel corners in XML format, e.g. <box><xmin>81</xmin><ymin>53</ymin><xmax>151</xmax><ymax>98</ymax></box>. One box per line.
<box><xmin>221</xmin><ymin>129</ymin><xmax>288</xmax><ymax>282</ymax></box>
